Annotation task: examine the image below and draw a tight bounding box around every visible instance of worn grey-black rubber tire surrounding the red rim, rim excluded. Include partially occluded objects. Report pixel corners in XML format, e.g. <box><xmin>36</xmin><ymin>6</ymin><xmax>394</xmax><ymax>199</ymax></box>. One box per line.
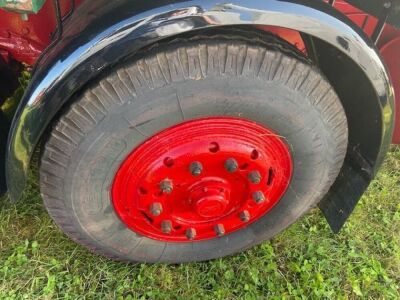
<box><xmin>40</xmin><ymin>35</ymin><xmax>347</xmax><ymax>263</ymax></box>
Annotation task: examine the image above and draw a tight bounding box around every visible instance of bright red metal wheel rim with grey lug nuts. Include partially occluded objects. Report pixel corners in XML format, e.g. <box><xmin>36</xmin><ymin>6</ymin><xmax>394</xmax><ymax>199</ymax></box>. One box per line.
<box><xmin>112</xmin><ymin>117</ymin><xmax>293</xmax><ymax>242</ymax></box>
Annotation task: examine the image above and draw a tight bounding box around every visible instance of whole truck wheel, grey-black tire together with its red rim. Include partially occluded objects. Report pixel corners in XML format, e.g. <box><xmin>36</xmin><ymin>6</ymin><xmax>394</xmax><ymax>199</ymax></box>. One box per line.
<box><xmin>40</xmin><ymin>34</ymin><xmax>348</xmax><ymax>263</ymax></box>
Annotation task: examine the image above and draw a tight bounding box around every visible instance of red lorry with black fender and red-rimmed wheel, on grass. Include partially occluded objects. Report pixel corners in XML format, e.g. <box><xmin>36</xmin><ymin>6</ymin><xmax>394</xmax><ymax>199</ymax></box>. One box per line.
<box><xmin>0</xmin><ymin>0</ymin><xmax>400</xmax><ymax>263</ymax></box>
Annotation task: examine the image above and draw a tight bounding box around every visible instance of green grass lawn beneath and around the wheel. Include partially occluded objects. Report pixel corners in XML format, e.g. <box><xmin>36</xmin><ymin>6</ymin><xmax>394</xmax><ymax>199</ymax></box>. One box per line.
<box><xmin>0</xmin><ymin>148</ymin><xmax>400</xmax><ymax>299</ymax></box>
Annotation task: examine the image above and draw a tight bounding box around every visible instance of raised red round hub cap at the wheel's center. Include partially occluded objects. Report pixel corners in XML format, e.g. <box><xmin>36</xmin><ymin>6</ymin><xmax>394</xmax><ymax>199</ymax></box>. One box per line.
<box><xmin>190</xmin><ymin>178</ymin><xmax>230</xmax><ymax>219</ymax></box>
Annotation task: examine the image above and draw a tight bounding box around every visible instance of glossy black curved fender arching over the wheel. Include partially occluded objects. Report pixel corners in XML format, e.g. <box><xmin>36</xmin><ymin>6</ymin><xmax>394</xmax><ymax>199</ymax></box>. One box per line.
<box><xmin>6</xmin><ymin>0</ymin><xmax>394</xmax><ymax>230</ymax></box>
